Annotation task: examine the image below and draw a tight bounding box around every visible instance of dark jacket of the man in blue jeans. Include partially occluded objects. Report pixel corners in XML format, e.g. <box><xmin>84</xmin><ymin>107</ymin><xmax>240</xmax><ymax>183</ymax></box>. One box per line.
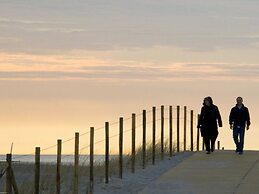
<box><xmin>229</xmin><ymin>105</ymin><xmax>251</xmax><ymax>127</ymax></box>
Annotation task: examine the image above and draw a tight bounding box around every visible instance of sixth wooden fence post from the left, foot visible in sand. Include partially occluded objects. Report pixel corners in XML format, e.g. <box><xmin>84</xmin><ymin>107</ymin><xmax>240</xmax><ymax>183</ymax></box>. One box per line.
<box><xmin>105</xmin><ymin>122</ymin><xmax>110</xmax><ymax>184</ymax></box>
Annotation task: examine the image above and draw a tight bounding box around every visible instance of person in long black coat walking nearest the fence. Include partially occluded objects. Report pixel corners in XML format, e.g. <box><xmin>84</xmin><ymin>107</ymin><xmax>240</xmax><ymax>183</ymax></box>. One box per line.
<box><xmin>197</xmin><ymin>96</ymin><xmax>222</xmax><ymax>154</ymax></box>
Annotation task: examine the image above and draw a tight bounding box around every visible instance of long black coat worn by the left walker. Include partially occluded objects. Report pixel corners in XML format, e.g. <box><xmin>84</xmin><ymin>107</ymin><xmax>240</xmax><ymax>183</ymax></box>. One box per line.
<box><xmin>198</xmin><ymin>104</ymin><xmax>222</xmax><ymax>137</ymax></box>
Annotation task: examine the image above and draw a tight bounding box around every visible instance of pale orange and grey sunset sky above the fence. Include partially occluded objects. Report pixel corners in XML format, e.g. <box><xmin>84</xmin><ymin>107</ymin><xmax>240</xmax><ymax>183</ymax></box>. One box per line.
<box><xmin>0</xmin><ymin>0</ymin><xmax>259</xmax><ymax>154</ymax></box>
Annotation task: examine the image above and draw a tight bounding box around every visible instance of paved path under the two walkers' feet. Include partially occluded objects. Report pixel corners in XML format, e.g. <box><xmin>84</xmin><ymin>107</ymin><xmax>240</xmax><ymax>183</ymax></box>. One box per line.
<box><xmin>140</xmin><ymin>151</ymin><xmax>259</xmax><ymax>194</ymax></box>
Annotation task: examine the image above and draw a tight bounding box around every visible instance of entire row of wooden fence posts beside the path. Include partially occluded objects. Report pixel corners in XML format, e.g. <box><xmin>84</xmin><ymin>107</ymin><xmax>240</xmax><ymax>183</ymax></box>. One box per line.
<box><xmin>6</xmin><ymin>105</ymin><xmax>217</xmax><ymax>194</ymax></box>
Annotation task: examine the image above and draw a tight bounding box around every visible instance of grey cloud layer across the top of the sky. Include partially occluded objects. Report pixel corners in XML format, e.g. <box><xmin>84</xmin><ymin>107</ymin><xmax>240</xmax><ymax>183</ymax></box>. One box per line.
<box><xmin>0</xmin><ymin>0</ymin><xmax>259</xmax><ymax>53</ymax></box>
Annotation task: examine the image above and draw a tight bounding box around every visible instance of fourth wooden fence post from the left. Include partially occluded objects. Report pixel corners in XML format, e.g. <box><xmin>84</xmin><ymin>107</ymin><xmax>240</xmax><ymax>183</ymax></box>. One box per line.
<box><xmin>73</xmin><ymin>132</ymin><xmax>79</xmax><ymax>194</ymax></box>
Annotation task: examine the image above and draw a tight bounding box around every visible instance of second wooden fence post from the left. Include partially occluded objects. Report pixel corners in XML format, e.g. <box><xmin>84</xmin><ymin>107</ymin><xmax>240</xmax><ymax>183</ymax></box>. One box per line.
<box><xmin>34</xmin><ymin>147</ymin><xmax>40</xmax><ymax>194</ymax></box>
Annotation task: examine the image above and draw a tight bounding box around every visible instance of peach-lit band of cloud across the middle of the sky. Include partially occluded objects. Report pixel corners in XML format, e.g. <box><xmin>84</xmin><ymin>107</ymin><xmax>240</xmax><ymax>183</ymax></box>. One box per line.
<box><xmin>0</xmin><ymin>54</ymin><xmax>259</xmax><ymax>82</ymax></box>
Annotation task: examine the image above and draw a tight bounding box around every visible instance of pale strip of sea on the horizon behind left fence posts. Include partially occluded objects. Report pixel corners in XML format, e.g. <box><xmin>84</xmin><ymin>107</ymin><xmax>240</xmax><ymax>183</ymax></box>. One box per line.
<box><xmin>0</xmin><ymin>155</ymin><xmax>118</xmax><ymax>165</ymax></box>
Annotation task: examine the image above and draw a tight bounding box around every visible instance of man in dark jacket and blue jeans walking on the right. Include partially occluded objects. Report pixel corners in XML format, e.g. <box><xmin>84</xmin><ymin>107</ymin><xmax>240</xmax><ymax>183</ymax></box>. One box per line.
<box><xmin>229</xmin><ymin>97</ymin><xmax>251</xmax><ymax>154</ymax></box>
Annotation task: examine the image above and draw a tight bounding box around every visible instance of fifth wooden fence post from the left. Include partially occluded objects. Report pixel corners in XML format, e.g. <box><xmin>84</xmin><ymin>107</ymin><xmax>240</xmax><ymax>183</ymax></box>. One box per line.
<box><xmin>89</xmin><ymin>127</ymin><xmax>94</xmax><ymax>194</ymax></box>
